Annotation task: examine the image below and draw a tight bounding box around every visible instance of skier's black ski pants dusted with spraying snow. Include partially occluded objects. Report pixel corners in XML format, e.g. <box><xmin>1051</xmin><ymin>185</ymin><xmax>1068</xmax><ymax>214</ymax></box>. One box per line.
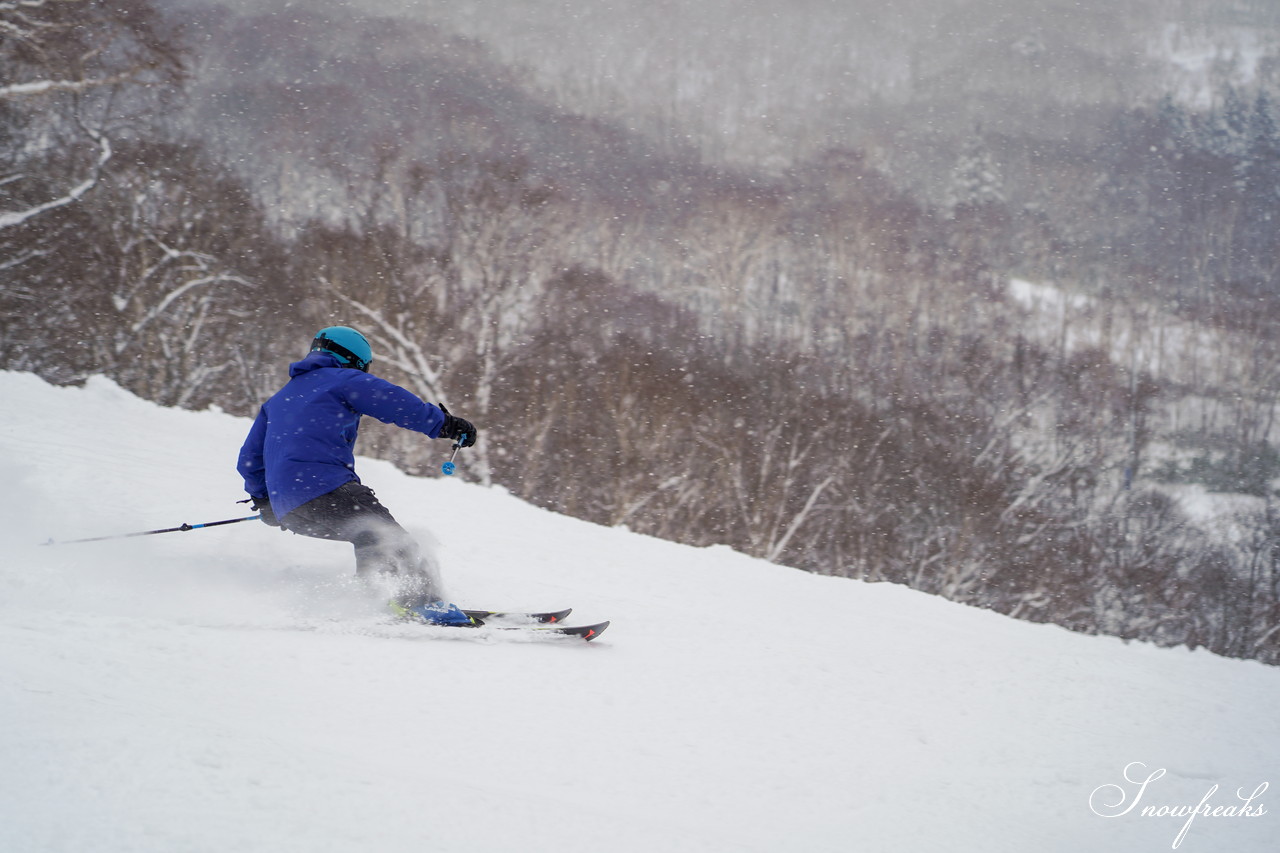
<box><xmin>280</xmin><ymin>480</ymin><xmax>435</xmax><ymax>603</ymax></box>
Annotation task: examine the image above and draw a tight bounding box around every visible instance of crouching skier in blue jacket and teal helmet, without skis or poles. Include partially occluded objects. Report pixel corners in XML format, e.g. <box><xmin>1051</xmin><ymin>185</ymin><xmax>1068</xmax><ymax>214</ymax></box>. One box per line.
<box><xmin>238</xmin><ymin>325</ymin><xmax>476</xmax><ymax>625</ymax></box>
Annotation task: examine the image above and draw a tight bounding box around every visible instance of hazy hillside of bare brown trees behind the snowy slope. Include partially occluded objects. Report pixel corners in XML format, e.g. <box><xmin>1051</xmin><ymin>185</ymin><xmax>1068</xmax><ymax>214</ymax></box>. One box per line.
<box><xmin>0</xmin><ymin>0</ymin><xmax>1280</xmax><ymax>662</ymax></box>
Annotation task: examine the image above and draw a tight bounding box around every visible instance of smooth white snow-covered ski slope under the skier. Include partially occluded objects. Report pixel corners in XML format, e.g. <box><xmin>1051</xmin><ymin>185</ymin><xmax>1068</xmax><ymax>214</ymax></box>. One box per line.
<box><xmin>0</xmin><ymin>373</ymin><xmax>1280</xmax><ymax>853</ymax></box>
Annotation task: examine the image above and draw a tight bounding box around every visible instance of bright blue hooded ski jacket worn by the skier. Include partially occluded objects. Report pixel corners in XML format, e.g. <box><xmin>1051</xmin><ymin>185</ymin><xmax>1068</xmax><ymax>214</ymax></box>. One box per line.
<box><xmin>238</xmin><ymin>352</ymin><xmax>444</xmax><ymax>517</ymax></box>
